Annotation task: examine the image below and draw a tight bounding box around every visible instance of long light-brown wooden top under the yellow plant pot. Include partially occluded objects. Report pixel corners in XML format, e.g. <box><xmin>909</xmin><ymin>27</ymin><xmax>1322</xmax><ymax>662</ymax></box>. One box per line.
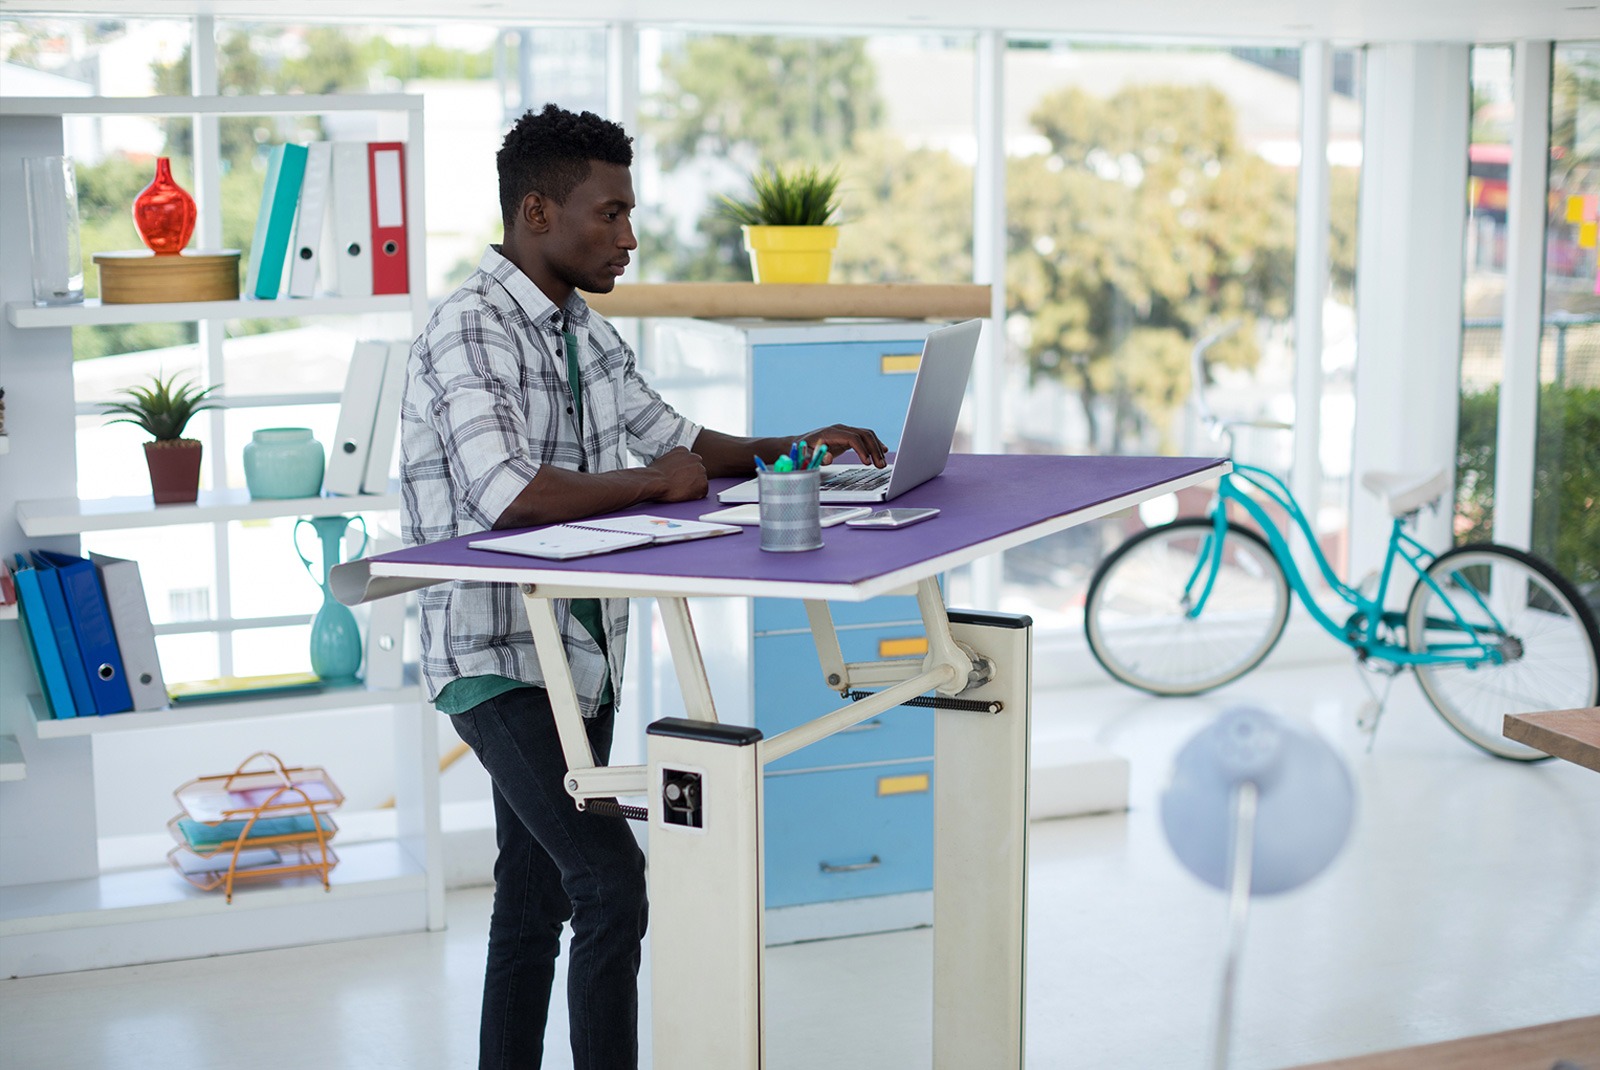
<box><xmin>584</xmin><ymin>283</ymin><xmax>989</xmax><ymax>320</ymax></box>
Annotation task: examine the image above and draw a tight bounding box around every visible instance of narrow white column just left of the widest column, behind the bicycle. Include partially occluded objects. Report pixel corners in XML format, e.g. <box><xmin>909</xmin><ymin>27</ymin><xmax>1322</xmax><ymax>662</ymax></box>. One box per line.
<box><xmin>1290</xmin><ymin>42</ymin><xmax>1333</xmax><ymax>576</ymax></box>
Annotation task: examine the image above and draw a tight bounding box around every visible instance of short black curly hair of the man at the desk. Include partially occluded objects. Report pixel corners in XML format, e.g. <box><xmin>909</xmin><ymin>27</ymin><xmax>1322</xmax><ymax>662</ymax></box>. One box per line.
<box><xmin>494</xmin><ymin>104</ymin><xmax>634</xmax><ymax>230</ymax></box>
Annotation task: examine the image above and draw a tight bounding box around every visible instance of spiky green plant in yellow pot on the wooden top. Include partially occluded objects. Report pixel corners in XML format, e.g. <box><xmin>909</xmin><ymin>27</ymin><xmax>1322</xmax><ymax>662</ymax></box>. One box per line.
<box><xmin>722</xmin><ymin>166</ymin><xmax>840</xmax><ymax>283</ymax></box>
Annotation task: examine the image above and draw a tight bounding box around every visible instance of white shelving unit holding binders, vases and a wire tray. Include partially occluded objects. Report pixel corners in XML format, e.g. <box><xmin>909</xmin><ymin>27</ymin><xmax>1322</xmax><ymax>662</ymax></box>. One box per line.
<box><xmin>0</xmin><ymin>70</ymin><xmax>443</xmax><ymax>976</ymax></box>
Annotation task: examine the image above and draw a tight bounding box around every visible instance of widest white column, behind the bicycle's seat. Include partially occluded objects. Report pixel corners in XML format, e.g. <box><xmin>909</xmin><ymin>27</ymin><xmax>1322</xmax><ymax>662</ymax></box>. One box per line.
<box><xmin>1350</xmin><ymin>43</ymin><xmax>1470</xmax><ymax>579</ymax></box>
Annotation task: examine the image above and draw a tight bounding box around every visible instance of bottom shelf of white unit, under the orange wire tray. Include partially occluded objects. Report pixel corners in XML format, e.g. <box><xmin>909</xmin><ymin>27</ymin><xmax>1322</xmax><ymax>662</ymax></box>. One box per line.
<box><xmin>0</xmin><ymin>840</ymin><xmax>426</xmax><ymax>937</ymax></box>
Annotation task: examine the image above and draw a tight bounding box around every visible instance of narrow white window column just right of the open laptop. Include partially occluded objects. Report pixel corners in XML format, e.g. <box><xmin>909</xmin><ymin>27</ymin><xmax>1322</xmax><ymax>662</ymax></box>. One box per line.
<box><xmin>973</xmin><ymin>30</ymin><xmax>1006</xmax><ymax>609</ymax></box>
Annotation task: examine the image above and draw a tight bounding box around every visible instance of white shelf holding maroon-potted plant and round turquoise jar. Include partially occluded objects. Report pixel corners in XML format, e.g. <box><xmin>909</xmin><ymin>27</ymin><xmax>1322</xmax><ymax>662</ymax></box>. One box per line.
<box><xmin>16</xmin><ymin>483</ymin><xmax>400</xmax><ymax>539</ymax></box>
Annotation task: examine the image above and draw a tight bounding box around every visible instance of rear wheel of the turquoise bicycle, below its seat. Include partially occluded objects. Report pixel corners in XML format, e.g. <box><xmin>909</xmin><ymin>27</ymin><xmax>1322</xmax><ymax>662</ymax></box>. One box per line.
<box><xmin>1406</xmin><ymin>545</ymin><xmax>1600</xmax><ymax>761</ymax></box>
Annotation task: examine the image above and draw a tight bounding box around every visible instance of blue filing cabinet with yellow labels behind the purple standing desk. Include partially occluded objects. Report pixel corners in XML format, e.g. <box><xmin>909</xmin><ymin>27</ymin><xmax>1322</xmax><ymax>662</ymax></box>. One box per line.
<box><xmin>642</xmin><ymin>320</ymin><xmax>938</xmax><ymax>936</ymax></box>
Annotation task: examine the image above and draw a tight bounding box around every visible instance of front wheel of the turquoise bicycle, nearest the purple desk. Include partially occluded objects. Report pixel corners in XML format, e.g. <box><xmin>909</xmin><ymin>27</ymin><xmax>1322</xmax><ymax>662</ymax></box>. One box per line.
<box><xmin>1083</xmin><ymin>517</ymin><xmax>1290</xmax><ymax>694</ymax></box>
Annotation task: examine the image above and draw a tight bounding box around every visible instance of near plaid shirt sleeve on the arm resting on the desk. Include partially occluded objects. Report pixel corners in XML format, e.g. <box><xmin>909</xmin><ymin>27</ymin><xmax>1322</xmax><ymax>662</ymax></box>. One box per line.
<box><xmin>418</xmin><ymin>309</ymin><xmax>542</xmax><ymax>529</ymax></box>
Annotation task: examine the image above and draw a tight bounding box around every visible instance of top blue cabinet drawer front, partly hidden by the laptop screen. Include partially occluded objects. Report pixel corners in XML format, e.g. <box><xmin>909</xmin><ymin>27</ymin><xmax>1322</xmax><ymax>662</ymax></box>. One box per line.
<box><xmin>750</xmin><ymin>336</ymin><xmax>922</xmax><ymax>449</ymax></box>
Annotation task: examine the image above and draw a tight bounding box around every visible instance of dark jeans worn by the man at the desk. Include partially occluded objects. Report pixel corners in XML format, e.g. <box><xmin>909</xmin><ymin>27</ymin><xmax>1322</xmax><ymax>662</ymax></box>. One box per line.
<box><xmin>451</xmin><ymin>688</ymin><xmax>646</xmax><ymax>1070</ymax></box>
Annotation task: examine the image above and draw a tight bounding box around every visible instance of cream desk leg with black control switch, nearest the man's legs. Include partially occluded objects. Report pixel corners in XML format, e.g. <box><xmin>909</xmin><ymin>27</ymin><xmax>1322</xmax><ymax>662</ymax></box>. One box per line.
<box><xmin>646</xmin><ymin>716</ymin><xmax>765</xmax><ymax>1070</ymax></box>
